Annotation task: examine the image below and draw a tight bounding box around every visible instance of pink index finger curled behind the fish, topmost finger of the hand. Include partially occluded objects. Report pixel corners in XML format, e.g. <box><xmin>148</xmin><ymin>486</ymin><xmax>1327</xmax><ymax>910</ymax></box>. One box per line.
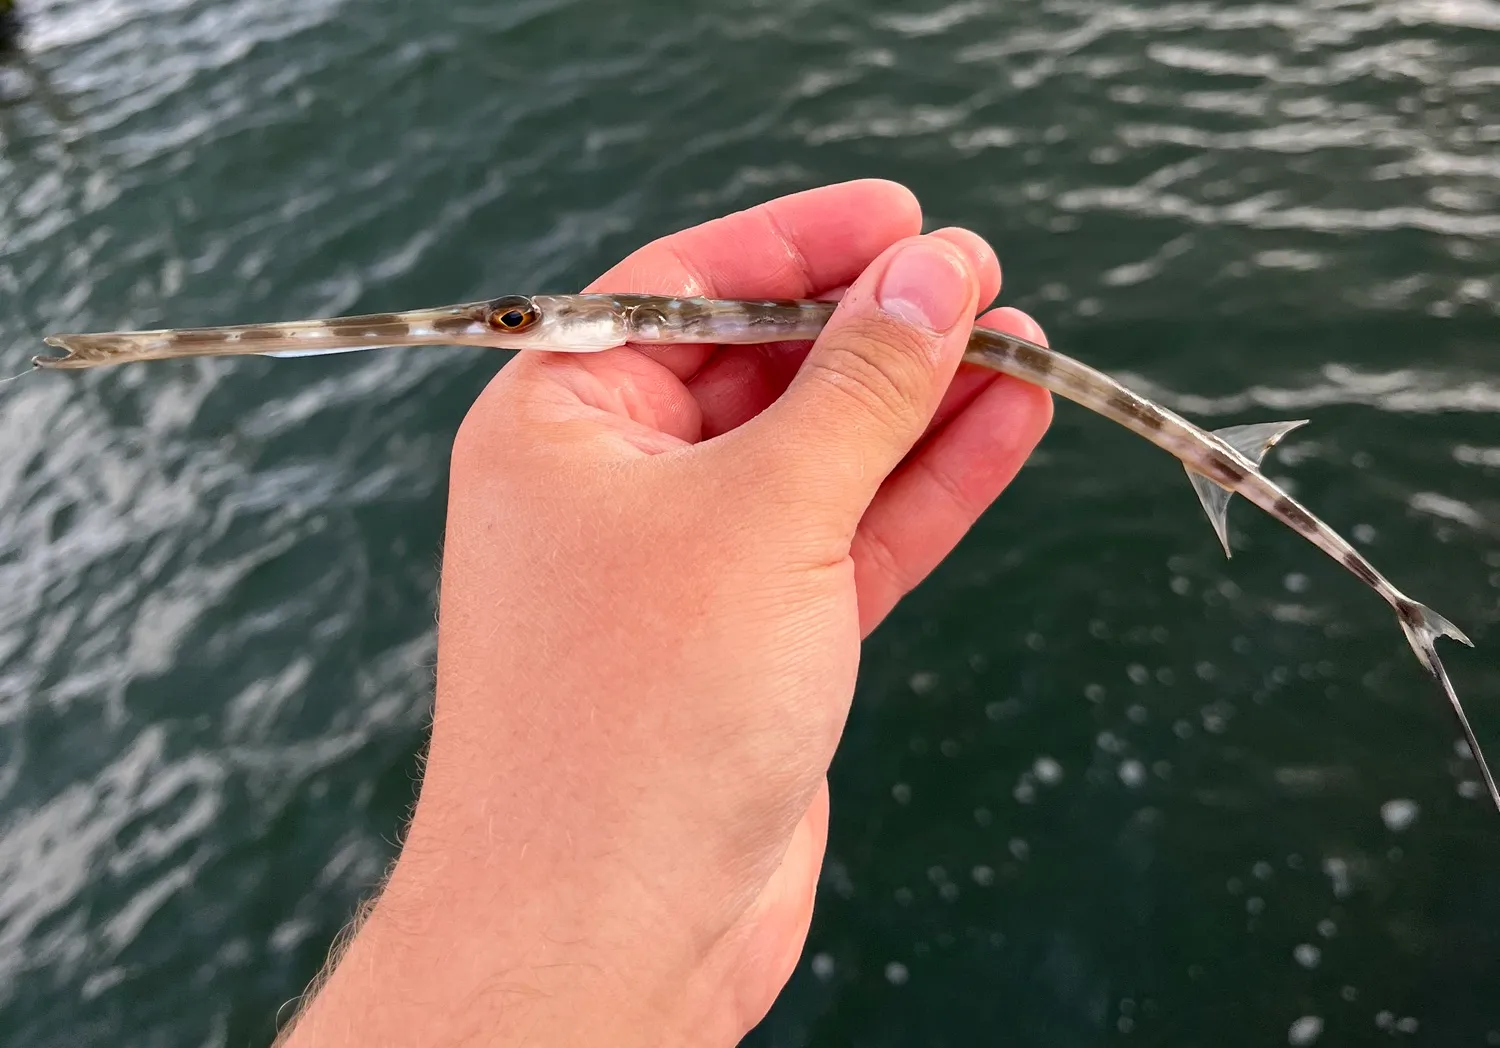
<box><xmin>587</xmin><ymin>178</ymin><xmax>923</xmax><ymax>379</ymax></box>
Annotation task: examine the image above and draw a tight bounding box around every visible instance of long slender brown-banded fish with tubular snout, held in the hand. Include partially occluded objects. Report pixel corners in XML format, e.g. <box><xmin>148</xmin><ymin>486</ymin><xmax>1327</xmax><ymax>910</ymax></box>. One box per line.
<box><xmin>33</xmin><ymin>294</ymin><xmax>1500</xmax><ymax>810</ymax></box>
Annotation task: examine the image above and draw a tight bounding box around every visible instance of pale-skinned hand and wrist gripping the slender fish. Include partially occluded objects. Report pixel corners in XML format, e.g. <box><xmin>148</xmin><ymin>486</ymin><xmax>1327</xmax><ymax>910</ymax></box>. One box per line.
<box><xmin>276</xmin><ymin>181</ymin><xmax>1052</xmax><ymax>1048</ymax></box>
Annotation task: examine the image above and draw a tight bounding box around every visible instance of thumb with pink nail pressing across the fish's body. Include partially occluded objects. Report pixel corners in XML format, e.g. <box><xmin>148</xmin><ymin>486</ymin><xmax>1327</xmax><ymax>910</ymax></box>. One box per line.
<box><xmin>735</xmin><ymin>235</ymin><xmax>993</xmax><ymax>535</ymax></box>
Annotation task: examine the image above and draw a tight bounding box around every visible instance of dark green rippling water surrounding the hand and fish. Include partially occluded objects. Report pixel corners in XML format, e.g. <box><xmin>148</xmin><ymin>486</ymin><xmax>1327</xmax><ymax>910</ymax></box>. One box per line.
<box><xmin>0</xmin><ymin>0</ymin><xmax>1500</xmax><ymax>1048</ymax></box>
